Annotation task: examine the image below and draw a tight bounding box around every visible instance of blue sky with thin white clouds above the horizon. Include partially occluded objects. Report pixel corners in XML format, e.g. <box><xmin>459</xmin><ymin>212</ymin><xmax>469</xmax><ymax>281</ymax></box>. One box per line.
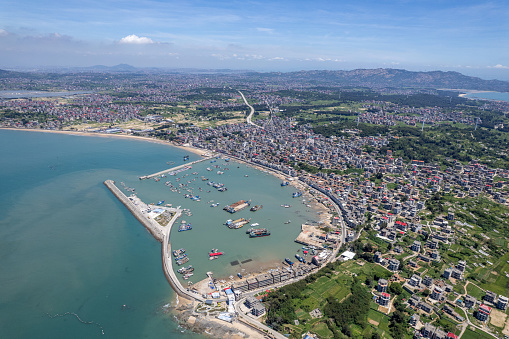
<box><xmin>0</xmin><ymin>0</ymin><xmax>509</xmax><ymax>80</ymax></box>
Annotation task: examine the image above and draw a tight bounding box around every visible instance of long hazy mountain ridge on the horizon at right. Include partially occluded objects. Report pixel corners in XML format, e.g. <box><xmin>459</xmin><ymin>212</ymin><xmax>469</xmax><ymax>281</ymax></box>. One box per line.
<box><xmin>274</xmin><ymin>68</ymin><xmax>509</xmax><ymax>92</ymax></box>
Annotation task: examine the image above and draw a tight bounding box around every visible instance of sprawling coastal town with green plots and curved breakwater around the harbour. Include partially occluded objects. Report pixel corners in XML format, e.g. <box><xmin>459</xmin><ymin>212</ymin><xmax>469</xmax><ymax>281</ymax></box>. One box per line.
<box><xmin>0</xmin><ymin>69</ymin><xmax>509</xmax><ymax>339</ymax></box>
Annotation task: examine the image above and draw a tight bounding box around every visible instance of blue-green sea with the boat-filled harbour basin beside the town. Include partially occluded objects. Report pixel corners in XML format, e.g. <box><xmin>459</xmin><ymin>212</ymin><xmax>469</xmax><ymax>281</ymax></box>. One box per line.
<box><xmin>0</xmin><ymin>130</ymin><xmax>316</xmax><ymax>339</ymax></box>
